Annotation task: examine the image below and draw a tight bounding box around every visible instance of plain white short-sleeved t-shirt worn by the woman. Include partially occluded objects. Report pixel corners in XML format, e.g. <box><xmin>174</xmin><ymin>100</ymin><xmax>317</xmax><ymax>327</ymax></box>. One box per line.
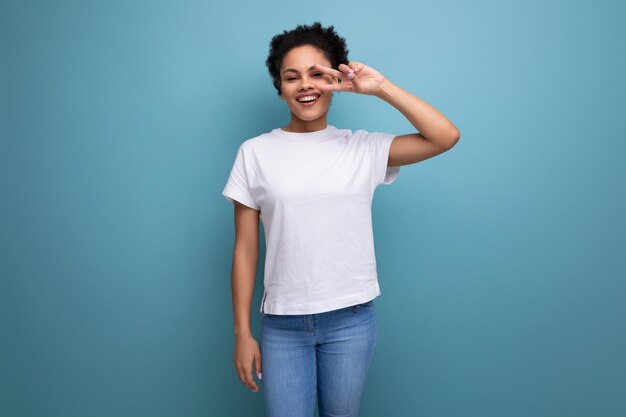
<box><xmin>222</xmin><ymin>124</ymin><xmax>400</xmax><ymax>314</ymax></box>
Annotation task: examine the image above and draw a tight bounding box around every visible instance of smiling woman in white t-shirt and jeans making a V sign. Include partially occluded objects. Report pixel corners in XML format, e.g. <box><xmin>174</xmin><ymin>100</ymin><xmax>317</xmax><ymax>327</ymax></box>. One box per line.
<box><xmin>223</xmin><ymin>22</ymin><xmax>460</xmax><ymax>417</ymax></box>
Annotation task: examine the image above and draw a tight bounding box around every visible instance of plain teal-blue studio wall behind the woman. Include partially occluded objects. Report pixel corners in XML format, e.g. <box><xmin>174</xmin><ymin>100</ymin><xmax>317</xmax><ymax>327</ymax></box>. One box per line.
<box><xmin>0</xmin><ymin>0</ymin><xmax>626</xmax><ymax>417</ymax></box>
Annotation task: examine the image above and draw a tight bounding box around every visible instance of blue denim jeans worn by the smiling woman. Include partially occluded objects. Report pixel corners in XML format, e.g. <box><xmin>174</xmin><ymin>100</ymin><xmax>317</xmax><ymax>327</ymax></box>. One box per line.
<box><xmin>259</xmin><ymin>300</ymin><xmax>378</xmax><ymax>417</ymax></box>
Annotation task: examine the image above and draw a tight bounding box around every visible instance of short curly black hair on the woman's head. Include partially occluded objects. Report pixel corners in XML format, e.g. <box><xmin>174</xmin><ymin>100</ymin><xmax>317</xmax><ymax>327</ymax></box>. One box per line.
<box><xmin>265</xmin><ymin>22</ymin><xmax>349</xmax><ymax>96</ymax></box>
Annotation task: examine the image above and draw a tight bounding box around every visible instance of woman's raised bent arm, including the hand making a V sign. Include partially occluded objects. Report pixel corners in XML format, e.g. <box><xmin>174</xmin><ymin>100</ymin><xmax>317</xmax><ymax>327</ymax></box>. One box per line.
<box><xmin>317</xmin><ymin>61</ymin><xmax>461</xmax><ymax>166</ymax></box>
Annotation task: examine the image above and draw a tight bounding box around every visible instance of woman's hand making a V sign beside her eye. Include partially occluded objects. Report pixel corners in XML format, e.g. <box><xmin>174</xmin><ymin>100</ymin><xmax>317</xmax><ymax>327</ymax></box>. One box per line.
<box><xmin>315</xmin><ymin>61</ymin><xmax>385</xmax><ymax>96</ymax></box>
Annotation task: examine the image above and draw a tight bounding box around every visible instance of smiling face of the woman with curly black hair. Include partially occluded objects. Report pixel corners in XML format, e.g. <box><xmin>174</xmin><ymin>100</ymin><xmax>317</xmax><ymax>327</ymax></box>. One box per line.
<box><xmin>280</xmin><ymin>45</ymin><xmax>334</xmax><ymax>122</ymax></box>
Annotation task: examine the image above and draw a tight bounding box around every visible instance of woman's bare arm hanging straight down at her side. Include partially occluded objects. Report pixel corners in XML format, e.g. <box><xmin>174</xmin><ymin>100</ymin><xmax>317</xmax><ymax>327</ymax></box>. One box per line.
<box><xmin>232</xmin><ymin>201</ymin><xmax>261</xmax><ymax>392</ymax></box>
